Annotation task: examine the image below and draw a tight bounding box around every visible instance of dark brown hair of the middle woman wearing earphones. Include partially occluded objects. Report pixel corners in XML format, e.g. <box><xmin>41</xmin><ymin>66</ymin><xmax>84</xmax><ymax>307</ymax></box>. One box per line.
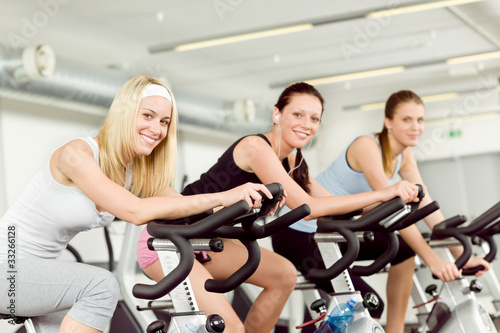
<box><xmin>274</xmin><ymin>82</ymin><xmax>324</xmax><ymax>193</ymax></box>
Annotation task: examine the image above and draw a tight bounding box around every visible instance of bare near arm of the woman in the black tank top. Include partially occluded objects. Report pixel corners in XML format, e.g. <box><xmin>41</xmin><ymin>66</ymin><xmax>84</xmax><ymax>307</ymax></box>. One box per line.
<box><xmin>234</xmin><ymin>136</ymin><xmax>416</xmax><ymax>219</ymax></box>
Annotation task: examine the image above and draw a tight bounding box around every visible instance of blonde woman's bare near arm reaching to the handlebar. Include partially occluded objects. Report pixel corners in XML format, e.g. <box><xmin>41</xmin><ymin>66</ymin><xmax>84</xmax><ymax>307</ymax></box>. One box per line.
<box><xmin>50</xmin><ymin>140</ymin><xmax>271</xmax><ymax>225</ymax></box>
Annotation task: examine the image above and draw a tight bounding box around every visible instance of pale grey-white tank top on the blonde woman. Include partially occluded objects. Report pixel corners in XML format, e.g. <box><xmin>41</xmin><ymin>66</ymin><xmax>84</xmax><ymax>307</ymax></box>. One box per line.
<box><xmin>0</xmin><ymin>137</ymin><xmax>114</xmax><ymax>263</ymax></box>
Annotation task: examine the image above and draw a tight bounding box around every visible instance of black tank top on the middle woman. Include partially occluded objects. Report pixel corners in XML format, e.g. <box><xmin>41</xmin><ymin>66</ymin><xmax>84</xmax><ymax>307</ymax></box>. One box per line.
<box><xmin>182</xmin><ymin>134</ymin><xmax>290</xmax><ymax>195</ymax></box>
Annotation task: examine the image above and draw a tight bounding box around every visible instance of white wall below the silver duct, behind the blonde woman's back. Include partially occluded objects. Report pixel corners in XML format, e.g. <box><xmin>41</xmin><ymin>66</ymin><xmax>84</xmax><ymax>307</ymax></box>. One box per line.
<box><xmin>0</xmin><ymin>99</ymin><xmax>101</xmax><ymax>209</ymax></box>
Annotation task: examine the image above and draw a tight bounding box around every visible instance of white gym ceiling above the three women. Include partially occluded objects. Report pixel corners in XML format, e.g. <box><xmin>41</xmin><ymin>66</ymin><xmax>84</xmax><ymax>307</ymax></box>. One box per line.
<box><xmin>0</xmin><ymin>0</ymin><xmax>500</xmax><ymax>113</ymax></box>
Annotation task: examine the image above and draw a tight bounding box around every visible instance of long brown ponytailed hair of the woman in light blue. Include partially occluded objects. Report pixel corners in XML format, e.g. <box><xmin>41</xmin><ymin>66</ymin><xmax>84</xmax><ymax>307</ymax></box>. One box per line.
<box><xmin>377</xmin><ymin>90</ymin><xmax>424</xmax><ymax>174</ymax></box>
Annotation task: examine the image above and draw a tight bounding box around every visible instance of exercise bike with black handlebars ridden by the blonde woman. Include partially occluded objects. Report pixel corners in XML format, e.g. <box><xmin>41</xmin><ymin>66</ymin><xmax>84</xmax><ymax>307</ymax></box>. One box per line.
<box><xmin>111</xmin><ymin>183</ymin><xmax>310</xmax><ymax>332</ymax></box>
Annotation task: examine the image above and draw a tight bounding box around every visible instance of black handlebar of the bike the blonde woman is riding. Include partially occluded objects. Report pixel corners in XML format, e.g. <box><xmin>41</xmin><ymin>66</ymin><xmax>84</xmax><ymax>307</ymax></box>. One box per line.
<box><xmin>132</xmin><ymin>183</ymin><xmax>311</xmax><ymax>299</ymax></box>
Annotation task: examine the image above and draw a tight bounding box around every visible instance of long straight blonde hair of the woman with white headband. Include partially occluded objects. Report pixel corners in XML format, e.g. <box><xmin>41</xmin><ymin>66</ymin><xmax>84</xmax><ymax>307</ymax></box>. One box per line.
<box><xmin>97</xmin><ymin>75</ymin><xmax>178</xmax><ymax>198</ymax></box>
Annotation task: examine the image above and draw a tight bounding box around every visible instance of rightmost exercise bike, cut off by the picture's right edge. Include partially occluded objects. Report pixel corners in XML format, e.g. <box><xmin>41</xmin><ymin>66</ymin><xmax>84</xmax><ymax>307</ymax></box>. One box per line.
<box><xmin>412</xmin><ymin>203</ymin><xmax>500</xmax><ymax>333</ymax></box>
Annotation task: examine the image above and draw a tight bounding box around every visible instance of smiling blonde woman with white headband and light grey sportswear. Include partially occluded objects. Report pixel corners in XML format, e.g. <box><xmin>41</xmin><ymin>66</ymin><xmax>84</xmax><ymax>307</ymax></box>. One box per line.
<box><xmin>0</xmin><ymin>76</ymin><xmax>270</xmax><ymax>333</ymax></box>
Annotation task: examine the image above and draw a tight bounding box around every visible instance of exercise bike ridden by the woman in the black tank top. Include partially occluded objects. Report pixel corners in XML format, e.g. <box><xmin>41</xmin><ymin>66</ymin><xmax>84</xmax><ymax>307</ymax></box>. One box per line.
<box><xmin>294</xmin><ymin>187</ymin><xmax>439</xmax><ymax>332</ymax></box>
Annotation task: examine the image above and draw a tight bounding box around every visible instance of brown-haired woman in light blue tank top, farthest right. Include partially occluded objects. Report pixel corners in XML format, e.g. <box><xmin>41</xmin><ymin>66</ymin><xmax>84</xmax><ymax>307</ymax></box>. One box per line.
<box><xmin>278</xmin><ymin>90</ymin><xmax>491</xmax><ymax>333</ymax></box>
